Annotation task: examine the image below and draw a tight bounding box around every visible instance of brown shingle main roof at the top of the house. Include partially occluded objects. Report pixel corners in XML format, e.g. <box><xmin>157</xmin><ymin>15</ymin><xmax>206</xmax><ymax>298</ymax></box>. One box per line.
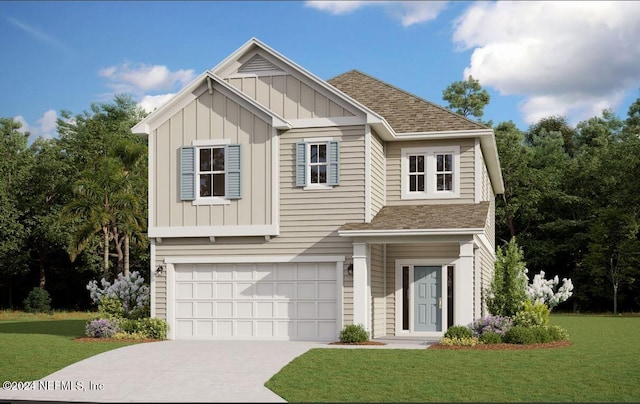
<box><xmin>327</xmin><ymin>70</ymin><xmax>487</xmax><ymax>133</ymax></box>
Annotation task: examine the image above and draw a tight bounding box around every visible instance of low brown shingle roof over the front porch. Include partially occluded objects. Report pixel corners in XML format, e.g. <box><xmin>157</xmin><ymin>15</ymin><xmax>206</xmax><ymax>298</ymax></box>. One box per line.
<box><xmin>340</xmin><ymin>202</ymin><xmax>489</xmax><ymax>230</ymax></box>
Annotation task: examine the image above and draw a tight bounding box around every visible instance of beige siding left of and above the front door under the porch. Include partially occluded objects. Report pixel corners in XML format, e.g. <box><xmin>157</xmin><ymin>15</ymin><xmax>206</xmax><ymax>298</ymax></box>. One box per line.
<box><xmin>386</xmin><ymin>244</ymin><xmax>460</xmax><ymax>335</ymax></box>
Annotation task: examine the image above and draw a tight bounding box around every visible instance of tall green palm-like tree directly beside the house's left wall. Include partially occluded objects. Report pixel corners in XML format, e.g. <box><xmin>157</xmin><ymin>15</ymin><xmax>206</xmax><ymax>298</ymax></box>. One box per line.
<box><xmin>58</xmin><ymin>96</ymin><xmax>147</xmax><ymax>279</ymax></box>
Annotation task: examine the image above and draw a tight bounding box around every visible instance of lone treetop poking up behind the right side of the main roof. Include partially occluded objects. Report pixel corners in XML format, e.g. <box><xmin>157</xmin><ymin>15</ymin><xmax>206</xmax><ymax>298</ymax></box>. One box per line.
<box><xmin>442</xmin><ymin>76</ymin><xmax>491</xmax><ymax>120</ymax></box>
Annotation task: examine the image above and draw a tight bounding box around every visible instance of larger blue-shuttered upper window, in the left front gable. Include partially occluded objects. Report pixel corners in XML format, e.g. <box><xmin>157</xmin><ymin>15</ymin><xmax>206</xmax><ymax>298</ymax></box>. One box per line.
<box><xmin>179</xmin><ymin>141</ymin><xmax>241</xmax><ymax>205</ymax></box>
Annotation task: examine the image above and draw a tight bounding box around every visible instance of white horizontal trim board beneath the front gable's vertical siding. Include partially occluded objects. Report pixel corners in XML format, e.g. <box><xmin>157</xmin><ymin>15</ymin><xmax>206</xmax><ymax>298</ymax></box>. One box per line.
<box><xmin>148</xmin><ymin>224</ymin><xmax>280</xmax><ymax>238</ymax></box>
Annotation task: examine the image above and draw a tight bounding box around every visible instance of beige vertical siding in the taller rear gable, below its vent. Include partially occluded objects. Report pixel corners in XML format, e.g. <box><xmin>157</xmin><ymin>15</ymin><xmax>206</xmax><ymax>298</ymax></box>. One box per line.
<box><xmin>227</xmin><ymin>74</ymin><xmax>354</xmax><ymax>119</ymax></box>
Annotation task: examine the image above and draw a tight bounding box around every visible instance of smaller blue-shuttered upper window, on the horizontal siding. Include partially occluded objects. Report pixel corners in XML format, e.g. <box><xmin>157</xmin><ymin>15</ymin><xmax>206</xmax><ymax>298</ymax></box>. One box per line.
<box><xmin>296</xmin><ymin>139</ymin><xmax>340</xmax><ymax>189</ymax></box>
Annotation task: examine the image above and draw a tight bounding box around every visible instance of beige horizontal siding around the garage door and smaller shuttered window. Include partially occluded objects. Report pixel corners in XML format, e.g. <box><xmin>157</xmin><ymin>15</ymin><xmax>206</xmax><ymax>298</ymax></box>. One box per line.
<box><xmin>156</xmin><ymin>126</ymin><xmax>364</xmax><ymax>323</ymax></box>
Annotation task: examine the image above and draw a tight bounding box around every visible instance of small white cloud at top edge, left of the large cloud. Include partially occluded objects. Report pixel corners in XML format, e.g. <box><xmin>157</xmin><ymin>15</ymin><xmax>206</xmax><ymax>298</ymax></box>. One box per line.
<box><xmin>306</xmin><ymin>1</ymin><xmax>447</xmax><ymax>27</ymax></box>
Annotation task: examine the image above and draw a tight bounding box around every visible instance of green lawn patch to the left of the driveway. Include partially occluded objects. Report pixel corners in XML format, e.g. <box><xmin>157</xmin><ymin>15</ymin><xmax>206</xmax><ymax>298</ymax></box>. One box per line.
<box><xmin>0</xmin><ymin>311</ymin><xmax>131</xmax><ymax>381</ymax></box>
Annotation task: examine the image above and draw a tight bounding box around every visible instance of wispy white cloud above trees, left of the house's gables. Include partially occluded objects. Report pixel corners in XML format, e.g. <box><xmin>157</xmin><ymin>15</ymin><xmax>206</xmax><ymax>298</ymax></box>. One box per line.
<box><xmin>98</xmin><ymin>63</ymin><xmax>195</xmax><ymax>94</ymax></box>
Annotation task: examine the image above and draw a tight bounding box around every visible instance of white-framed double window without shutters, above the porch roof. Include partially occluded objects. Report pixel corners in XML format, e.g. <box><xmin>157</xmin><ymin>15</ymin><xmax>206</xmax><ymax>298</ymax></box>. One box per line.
<box><xmin>401</xmin><ymin>146</ymin><xmax>460</xmax><ymax>199</ymax></box>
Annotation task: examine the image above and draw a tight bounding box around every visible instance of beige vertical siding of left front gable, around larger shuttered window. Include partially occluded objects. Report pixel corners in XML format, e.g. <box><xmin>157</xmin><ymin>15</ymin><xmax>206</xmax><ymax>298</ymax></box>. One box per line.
<box><xmin>158</xmin><ymin>91</ymin><xmax>273</xmax><ymax>227</ymax></box>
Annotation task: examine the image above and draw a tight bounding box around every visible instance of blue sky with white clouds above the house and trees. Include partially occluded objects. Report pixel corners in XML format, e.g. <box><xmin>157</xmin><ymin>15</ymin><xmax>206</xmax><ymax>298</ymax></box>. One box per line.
<box><xmin>0</xmin><ymin>1</ymin><xmax>640</xmax><ymax>137</ymax></box>
